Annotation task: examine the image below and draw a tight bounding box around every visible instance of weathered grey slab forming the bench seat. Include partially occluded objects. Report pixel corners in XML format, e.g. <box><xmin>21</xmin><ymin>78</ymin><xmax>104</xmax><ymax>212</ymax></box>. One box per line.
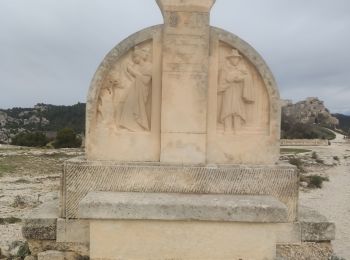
<box><xmin>79</xmin><ymin>192</ymin><xmax>288</xmax><ymax>223</ymax></box>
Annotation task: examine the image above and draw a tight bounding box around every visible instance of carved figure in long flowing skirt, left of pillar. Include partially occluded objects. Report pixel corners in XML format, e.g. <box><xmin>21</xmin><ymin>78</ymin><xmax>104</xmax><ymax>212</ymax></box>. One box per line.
<box><xmin>114</xmin><ymin>47</ymin><xmax>152</xmax><ymax>132</ymax></box>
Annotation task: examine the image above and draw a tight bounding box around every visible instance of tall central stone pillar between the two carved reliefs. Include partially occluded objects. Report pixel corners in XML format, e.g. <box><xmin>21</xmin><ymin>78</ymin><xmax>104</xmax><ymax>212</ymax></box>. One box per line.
<box><xmin>157</xmin><ymin>0</ymin><xmax>215</xmax><ymax>163</ymax></box>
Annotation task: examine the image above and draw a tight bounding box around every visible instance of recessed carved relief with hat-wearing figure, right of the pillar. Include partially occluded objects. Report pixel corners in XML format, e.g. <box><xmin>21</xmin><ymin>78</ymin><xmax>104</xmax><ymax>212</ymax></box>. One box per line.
<box><xmin>217</xmin><ymin>43</ymin><xmax>269</xmax><ymax>134</ymax></box>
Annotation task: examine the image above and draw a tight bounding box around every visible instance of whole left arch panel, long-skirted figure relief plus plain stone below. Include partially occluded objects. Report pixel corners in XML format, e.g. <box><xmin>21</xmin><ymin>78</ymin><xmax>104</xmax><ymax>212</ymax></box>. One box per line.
<box><xmin>87</xmin><ymin>34</ymin><xmax>162</xmax><ymax>161</ymax></box>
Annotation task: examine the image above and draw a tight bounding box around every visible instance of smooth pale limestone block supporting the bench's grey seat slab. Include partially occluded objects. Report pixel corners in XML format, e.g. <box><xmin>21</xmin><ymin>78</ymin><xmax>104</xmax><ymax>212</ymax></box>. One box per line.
<box><xmin>90</xmin><ymin>220</ymin><xmax>276</xmax><ymax>260</ymax></box>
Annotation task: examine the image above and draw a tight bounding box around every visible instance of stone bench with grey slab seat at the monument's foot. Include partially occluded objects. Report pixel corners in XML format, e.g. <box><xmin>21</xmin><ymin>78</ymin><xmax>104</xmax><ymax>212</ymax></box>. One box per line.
<box><xmin>79</xmin><ymin>192</ymin><xmax>288</xmax><ymax>260</ymax></box>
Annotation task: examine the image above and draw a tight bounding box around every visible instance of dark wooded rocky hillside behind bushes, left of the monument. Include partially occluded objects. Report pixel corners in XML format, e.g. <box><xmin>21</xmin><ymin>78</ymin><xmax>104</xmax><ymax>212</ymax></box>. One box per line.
<box><xmin>0</xmin><ymin>103</ymin><xmax>85</xmax><ymax>143</ymax></box>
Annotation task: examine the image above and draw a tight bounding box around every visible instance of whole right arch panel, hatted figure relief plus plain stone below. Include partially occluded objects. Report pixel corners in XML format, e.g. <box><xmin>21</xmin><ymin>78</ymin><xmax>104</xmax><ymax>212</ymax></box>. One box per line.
<box><xmin>207</xmin><ymin>38</ymin><xmax>277</xmax><ymax>164</ymax></box>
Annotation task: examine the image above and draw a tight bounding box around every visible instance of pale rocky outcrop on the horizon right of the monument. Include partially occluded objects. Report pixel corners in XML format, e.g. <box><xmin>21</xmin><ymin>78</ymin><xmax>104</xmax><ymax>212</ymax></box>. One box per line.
<box><xmin>282</xmin><ymin>97</ymin><xmax>339</xmax><ymax>127</ymax></box>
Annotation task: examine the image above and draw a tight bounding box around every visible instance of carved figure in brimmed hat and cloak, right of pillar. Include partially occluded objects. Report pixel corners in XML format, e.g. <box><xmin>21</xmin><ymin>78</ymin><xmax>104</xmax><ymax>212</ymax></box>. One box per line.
<box><xmin>218</xmin><ymin>49</ymin><xmax>254</xmax><ymax>133</ymax></box>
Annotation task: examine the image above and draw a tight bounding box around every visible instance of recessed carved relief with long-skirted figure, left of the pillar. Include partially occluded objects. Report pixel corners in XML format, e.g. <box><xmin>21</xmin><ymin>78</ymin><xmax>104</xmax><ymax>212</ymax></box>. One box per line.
<box><xmin>97</xmin><ymin>43</ymin><xmax>152</xmax><ymax>132</ymax></box>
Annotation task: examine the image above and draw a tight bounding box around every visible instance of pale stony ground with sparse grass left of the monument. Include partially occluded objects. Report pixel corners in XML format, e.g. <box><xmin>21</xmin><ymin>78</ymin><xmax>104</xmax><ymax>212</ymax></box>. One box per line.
<box><xmin>0</xmin><ymin>145</ymin><xmax>83</xmax><ymax>252</ymax></box>
